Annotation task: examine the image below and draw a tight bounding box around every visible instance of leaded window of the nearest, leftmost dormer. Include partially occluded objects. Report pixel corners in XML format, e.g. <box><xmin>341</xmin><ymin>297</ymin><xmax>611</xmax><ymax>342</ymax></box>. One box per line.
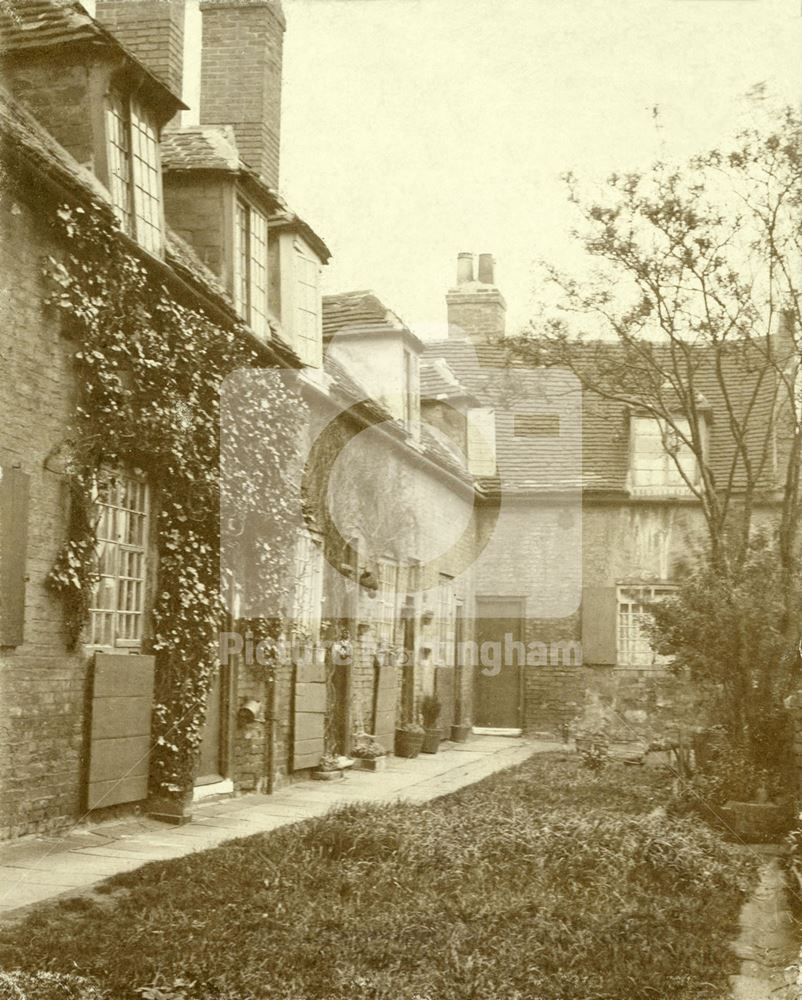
<box><xmin>106</xmin><ymin>93</ymin><xmax>162</xmax><ymax>254</ymax></box>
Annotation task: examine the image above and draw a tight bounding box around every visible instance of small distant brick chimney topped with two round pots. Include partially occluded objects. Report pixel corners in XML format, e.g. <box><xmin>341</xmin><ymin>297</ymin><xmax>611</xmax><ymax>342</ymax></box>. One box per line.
<box><xmin>446</xmin><ymin>253</ymin><xmax>507</xmax><ymax>344</ymax></box>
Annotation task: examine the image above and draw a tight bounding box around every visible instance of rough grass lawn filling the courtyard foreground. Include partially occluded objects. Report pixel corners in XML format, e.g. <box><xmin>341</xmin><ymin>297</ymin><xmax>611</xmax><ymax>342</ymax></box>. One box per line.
<box><xmin>0</xmin><ymin>754</ymin><xmax>753</xmax><ymax>1000</ymax></box>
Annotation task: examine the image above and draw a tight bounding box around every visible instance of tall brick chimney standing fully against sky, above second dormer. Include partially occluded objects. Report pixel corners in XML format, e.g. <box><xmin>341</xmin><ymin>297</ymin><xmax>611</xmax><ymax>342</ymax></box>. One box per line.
<box><xmin>200</xmin><ymin>0</ymin><xmax>285</xmax><ymax>188</ymax></box>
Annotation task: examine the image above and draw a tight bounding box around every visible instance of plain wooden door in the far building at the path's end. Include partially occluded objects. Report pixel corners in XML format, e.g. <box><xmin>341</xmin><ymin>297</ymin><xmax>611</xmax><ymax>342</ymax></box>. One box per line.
<box><xmin>474</xmin><ymin>597</ymin><xmax>523</xmax><ymax>729</ymax></box>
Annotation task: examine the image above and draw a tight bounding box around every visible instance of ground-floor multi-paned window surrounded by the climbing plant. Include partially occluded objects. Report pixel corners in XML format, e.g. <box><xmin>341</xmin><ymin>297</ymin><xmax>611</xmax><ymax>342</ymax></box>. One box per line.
<box><xmin>89</xmin><ymin>472</ymin><xmax>148</xmax><ymax>646</ymax></box>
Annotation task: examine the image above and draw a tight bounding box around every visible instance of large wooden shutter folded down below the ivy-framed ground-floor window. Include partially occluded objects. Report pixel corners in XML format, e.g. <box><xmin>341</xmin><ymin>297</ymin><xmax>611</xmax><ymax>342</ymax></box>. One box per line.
<box><xmin>87</xmin><ymin>653</ymin><xmax>154</xmax><ymax>809</ymax></box>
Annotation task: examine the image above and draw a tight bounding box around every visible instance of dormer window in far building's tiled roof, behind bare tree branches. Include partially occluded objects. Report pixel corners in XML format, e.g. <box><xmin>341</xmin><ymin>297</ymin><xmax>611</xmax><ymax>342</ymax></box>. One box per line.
<box><xmin>632</xmin><ymin>417</ymin><xmax>697</xmax><ymax>493</ymax></box>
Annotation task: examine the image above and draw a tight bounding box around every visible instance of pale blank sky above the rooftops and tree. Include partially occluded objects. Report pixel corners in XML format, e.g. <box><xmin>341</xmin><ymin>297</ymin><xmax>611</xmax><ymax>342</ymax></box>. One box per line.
<box><xmin>282</xmin><ymin>0</ymin><xmax>802</xmax><ymax>338</ymax></box>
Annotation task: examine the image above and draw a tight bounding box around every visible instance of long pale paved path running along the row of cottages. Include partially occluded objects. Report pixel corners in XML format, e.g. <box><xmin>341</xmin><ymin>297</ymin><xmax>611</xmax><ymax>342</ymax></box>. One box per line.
<box><xmin>0</xmin><ymin>736</ymin><xmax>562</xmax><ymax>919</ymax></box>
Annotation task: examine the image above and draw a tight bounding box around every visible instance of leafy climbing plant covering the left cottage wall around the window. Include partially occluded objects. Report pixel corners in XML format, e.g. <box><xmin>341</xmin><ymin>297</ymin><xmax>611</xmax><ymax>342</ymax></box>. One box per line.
<box><xmin>46</xmin><ymin>206</ymin><xmax>305</xmax><ymax>796</ymax></box>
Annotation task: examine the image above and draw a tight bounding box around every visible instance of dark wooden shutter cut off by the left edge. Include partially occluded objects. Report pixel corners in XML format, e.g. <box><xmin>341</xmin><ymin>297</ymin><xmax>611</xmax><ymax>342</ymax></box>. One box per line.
<box><xmin>0</xmin><ymin>467</ymin><xmax>30</xmax><ymax>646</ymax></box>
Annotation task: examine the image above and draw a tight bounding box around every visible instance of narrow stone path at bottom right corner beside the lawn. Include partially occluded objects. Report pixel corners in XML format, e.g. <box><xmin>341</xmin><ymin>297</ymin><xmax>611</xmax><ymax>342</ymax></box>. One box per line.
<box><xmin>730</xmin><ymin>857</ymin><xmax>802</xmax><ymax>1000</ymax></box>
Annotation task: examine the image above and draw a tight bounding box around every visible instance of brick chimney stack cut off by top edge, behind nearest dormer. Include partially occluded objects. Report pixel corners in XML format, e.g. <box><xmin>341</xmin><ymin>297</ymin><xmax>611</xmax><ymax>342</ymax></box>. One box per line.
<box><xmin>95</xmin><ymin>0</ymin><xmax>184</xmax><ymax>97</ymax></box>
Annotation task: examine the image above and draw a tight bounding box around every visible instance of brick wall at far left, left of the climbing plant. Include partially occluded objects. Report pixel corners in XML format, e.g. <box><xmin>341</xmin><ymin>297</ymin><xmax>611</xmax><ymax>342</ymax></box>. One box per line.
<box><xmin>0</xmin><ymin>195</ymin><xmax>87</xmax><ymax>836</ymax></box>
